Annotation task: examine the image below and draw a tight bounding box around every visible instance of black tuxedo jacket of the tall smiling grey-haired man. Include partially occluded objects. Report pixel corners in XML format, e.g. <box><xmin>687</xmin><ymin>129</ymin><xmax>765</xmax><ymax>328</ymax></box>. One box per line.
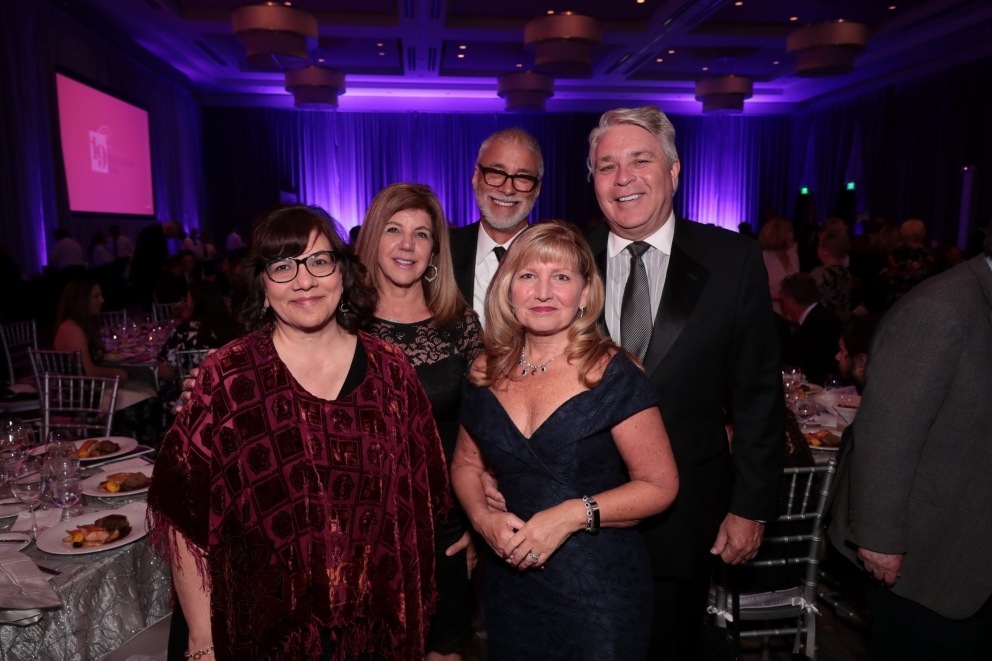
<box><xmin>588</xmin><ymin>218</ymin><xmax>785</xmax><ymax>578</ymax></box>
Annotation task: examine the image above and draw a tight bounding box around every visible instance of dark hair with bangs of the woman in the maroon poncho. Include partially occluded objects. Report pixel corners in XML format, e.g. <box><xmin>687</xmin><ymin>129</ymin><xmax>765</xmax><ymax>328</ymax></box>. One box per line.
<box><xmin>241</xmin><ymin>204</ymin><xmax>375</xmax><ymax>333</ymax></box>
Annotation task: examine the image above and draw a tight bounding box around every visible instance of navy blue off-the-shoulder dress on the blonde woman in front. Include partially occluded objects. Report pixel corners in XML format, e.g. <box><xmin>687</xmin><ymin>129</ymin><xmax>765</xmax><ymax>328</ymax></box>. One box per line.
<box><xmin>461</xmin><ymin>354</ymin><xmax>657</xmax><ymax>661</ymax></box>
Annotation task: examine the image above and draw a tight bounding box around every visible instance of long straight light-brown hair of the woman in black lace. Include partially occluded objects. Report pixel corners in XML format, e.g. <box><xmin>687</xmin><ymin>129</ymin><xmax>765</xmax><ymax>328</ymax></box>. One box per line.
<box><xmin>355</xmin><ymin>184</ymin><xmax>468</xmax><ymax>326</ymax></box>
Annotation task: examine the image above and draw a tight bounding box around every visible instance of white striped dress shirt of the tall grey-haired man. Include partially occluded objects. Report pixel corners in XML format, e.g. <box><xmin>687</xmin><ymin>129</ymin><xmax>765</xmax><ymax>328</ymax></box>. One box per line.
<box><xmin>606</xmin><ymin>212</ymin><xmax>675</xmax><ymax>344</ymax></box>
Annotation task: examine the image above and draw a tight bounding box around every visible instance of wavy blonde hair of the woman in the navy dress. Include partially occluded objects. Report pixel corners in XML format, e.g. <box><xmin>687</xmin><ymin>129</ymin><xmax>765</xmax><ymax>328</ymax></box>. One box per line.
<box><xmin>469</xmin><ymin>220</ymin><xmax>622</xmax><ymax>388</ymax></box>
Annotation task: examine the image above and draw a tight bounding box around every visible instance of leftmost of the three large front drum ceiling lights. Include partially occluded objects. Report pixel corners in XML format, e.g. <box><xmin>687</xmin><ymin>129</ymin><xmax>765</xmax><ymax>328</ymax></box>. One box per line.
<box><xmin>231</xmin><ymin>3</ymin><xmax>317</xmax><ymax>71</ymax></box>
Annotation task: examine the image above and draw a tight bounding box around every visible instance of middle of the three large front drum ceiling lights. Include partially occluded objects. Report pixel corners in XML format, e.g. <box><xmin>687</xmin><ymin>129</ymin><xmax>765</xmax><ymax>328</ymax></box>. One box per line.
<box><xmin>524</xmin><ymin>11</ymin><xmax>603</xmax><ymax>78</ymax></box>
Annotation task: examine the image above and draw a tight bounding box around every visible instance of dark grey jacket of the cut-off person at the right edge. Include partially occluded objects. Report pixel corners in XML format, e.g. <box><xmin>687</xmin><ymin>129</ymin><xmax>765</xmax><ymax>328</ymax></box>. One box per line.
<box><xmin>830</xmin><ymin>256</ymin><xmax>992</xmax><ymax>619</ymax></box>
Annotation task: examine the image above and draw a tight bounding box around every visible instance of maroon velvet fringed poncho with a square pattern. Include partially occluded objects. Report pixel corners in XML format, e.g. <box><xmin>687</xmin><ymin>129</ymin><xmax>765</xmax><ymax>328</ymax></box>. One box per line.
<box><xmin>148</xmin><ymin>330</ymin><xmax>447</xmax><ymax>659</ymax></box>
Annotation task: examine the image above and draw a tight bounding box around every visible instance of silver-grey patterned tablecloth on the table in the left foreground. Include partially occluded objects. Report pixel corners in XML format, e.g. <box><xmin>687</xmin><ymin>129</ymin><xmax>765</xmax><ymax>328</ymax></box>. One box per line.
<box><xmin>0</xmin><ymin>476</ymin><xmax>172</xmax><ymax>661</ymax></box>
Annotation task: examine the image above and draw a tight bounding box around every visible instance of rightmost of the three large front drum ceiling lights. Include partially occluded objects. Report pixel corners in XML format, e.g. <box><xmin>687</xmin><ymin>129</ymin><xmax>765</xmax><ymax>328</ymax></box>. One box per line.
<box><xmin>785</xmin><ymin>21</ymin><xmax>868</xmax><ymax>78</ymax></box>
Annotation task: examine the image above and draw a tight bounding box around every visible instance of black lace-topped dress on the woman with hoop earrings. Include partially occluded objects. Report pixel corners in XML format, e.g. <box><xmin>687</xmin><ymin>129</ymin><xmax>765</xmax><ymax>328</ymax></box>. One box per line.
<box><xmin>367</xmin><ymin>310</ymin><xmax>482</xmax><ymax>654</ymax></box>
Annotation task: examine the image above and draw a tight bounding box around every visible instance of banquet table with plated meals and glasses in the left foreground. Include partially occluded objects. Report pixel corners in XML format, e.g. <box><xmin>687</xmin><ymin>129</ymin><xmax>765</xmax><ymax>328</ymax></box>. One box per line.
<box><xmin>0</xmin><ymin>426</ymin><xmax>171</xmax><ymax>661</ymax></box>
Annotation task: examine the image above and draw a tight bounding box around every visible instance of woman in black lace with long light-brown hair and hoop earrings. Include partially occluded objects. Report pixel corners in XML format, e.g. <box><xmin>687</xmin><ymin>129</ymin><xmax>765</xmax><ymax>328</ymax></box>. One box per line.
<box><xmin>355</xmin><ymin>184</ymin><xmax>482</xmax><ymax>661</ymax></box>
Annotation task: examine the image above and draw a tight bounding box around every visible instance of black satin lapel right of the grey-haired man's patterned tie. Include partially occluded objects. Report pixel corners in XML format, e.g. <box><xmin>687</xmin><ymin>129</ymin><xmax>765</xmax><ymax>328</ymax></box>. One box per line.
<box><xmin>644</xmin><ymin>236</ymin><xmax>709</xmax><ymax>376</ymax></box>
